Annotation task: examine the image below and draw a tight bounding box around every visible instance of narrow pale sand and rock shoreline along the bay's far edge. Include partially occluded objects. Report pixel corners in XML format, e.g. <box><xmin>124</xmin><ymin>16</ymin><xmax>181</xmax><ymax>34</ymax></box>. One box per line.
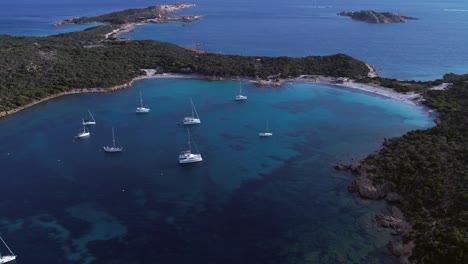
<box><xmin>0</xmin><ymin>69</ymin><xmax>435</xmax><ymax>118</ymax></box>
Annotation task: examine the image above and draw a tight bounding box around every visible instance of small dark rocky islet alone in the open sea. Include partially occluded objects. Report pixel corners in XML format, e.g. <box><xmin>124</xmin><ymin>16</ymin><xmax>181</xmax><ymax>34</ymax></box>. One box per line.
<box><xmin>338</xmin><ymin>10</ymin><xmax>417</xmax><ymax>24</ymax></box>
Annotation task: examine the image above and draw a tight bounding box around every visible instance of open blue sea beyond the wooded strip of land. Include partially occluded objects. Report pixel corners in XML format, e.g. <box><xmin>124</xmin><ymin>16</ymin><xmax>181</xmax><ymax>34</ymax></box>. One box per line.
<box><xmin>0</xmin><ymin>0</ymin><xmax>468</xmax><ymax>80</ymax></box>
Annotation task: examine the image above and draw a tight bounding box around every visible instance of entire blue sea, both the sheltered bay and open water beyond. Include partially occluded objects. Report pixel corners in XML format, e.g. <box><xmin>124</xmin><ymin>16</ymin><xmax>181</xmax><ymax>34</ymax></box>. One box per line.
<box><xmin>0</xmin><ymin>0</ymin><xmax>452</xmax><ymax>264</ymax></box>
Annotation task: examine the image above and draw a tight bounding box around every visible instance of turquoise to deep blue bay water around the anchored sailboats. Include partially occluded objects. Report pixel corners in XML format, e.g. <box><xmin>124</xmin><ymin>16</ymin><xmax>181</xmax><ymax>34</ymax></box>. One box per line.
<box><xmin>0</xmin><ymin>79</ymin><xmax>432</xmax><ymax>263</ymax></box>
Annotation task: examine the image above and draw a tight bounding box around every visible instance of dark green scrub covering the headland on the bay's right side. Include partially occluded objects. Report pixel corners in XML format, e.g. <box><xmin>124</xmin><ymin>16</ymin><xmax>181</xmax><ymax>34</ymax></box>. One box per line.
<box><xmin>363</xmin><ymin>74</ymin><xmax>468</xmax><ymax>263</ymax></box>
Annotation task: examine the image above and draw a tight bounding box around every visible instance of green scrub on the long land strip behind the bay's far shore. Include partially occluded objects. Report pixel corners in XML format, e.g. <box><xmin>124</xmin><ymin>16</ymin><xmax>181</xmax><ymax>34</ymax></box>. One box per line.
<box><xmin>0</xmin><ymin>26</ymin><xmax>368</xmax><ymax>111</ymax></box>
